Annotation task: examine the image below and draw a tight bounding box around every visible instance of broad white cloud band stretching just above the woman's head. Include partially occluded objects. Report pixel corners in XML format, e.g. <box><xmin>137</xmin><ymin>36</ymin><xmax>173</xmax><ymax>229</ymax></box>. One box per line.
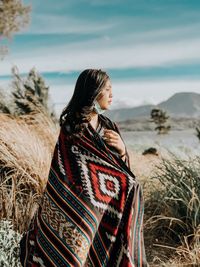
<box><xmin>0</xmin><ymin>34</ymin><xmax>200</xmax><ymax>75</ymax></box>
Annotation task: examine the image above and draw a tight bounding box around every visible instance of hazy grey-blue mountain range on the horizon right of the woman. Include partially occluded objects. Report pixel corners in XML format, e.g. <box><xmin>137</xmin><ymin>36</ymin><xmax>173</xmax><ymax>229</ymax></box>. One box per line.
<box><xmin>105</xmin><ymin>93</ymin><xmax>200</xmax><ymax>121</ymax></box>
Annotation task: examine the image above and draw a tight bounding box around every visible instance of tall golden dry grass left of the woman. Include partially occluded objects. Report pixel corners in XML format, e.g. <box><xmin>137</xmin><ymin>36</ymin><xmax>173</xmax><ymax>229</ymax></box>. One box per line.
<box><xmin>0</xmin><ymin>113</ymin><xmax>58</xmax><ymax>232</ymax></box>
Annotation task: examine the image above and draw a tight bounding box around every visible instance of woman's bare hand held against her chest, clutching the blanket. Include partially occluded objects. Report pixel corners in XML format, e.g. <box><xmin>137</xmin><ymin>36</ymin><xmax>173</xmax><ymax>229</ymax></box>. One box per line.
<box><xmin>103</xmin><ymin>129</ymin><xmax>126</xmax><ymax>155</ymax></box>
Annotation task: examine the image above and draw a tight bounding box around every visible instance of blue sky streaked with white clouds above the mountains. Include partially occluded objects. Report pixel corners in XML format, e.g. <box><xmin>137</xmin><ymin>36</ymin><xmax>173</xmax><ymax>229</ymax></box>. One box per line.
<box><xmin>0</xmin><ymin>0</ymin><xmax>200</xmax><ymax>112</ymax></box>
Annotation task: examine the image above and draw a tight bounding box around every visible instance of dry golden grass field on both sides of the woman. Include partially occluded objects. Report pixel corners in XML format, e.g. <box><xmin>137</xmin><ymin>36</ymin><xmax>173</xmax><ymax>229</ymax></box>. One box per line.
<box><xmin>0</xmin><ymin>113</ymin><xmax>200</xmax><ymax>267</ymax></box>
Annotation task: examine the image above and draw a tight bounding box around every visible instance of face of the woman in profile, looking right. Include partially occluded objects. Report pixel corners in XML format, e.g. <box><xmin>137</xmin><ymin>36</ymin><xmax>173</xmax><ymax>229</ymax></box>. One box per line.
<box><xmin>97</xmin><ymin>79</ymin><xmax>113</xmax><ymax>109</ymax></box>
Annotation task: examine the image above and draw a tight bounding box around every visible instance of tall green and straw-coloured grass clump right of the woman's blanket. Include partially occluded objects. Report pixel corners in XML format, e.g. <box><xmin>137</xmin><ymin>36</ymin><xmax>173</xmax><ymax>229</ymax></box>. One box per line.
<box><xmin>145</xmin><ymin>156</ymin><xmax>200</xmax><ymax>266</ymax></box>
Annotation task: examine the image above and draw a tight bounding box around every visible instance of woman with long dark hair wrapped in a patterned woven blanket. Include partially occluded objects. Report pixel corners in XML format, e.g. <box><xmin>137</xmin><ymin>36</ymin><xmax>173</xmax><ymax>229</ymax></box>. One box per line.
<box><xmin>20</xmin><ymin>69</ymin><xmax>147</xmax><ymax>267</ymax></box>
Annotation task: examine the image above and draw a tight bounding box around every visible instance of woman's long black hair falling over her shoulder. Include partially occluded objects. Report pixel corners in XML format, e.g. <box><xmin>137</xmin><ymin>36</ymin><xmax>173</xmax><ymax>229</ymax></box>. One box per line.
<box><xmin>59</xmin><ymin>69</ymin><xmax>109</xmax><ymax>139</ymax></box>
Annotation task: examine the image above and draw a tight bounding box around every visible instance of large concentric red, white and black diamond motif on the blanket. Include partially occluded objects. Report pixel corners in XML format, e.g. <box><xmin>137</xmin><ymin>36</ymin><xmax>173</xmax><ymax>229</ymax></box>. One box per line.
<box><xmin>76</xmin><ymin>148</ymin><xmax>130</xmax><ymax>218</ymax></box>
